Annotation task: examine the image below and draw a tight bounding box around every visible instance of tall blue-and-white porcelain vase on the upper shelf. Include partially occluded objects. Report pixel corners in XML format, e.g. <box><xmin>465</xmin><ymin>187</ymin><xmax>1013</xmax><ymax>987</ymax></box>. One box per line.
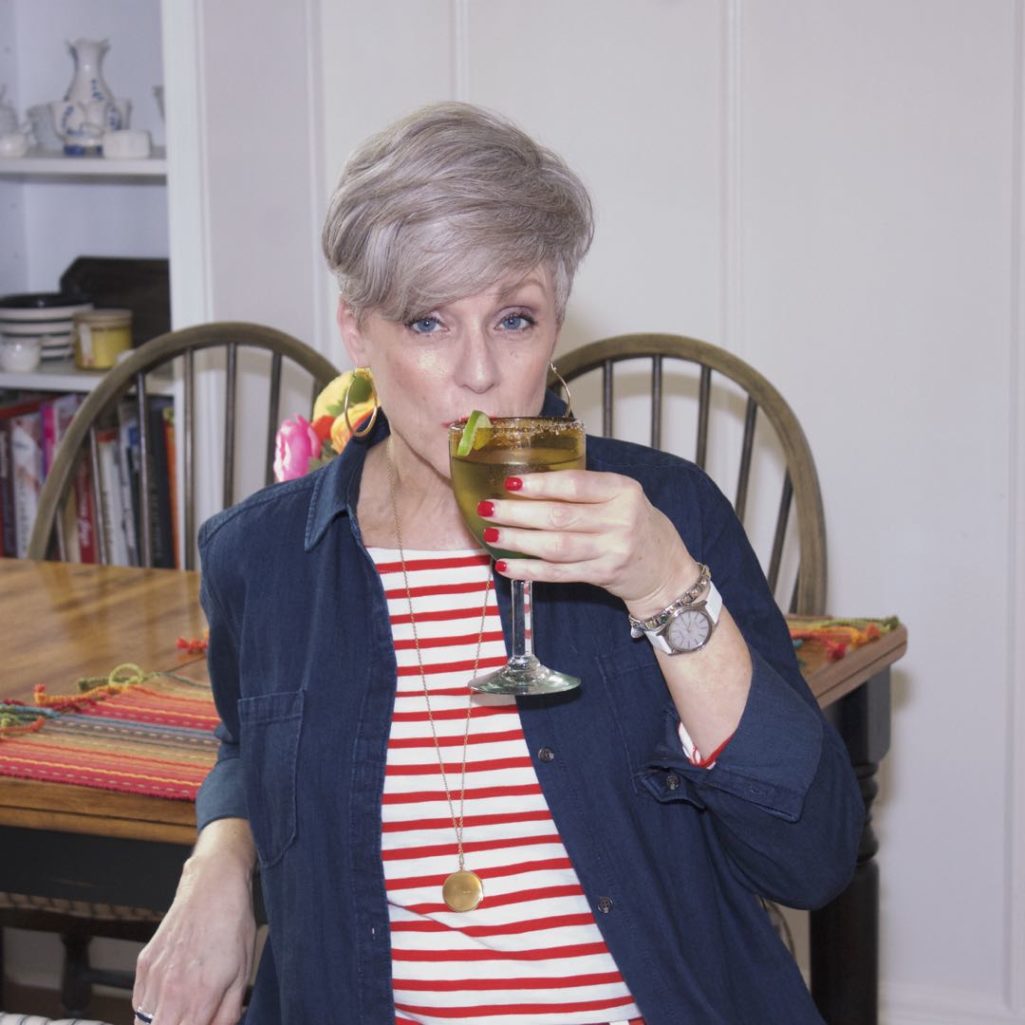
<box><xmin>50</xmin><ymin>39</ymin><xmax>131</xmax><ymax>157</ymax></box>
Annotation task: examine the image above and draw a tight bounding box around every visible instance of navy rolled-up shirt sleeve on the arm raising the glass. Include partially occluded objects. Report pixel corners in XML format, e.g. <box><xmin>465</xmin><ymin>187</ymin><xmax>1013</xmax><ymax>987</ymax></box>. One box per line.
<box><xmin>643</xmin><ymin>465</ymin><xmax>864</xmax><ymax>907</ymax></box>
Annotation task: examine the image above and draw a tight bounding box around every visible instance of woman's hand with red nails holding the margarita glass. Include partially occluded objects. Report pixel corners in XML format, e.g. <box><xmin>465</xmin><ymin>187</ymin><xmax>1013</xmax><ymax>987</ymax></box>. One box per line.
<box><xmin>478</xmin><ymin>469</ymin><xmax>698</xmax><ymax>617</ymax></box>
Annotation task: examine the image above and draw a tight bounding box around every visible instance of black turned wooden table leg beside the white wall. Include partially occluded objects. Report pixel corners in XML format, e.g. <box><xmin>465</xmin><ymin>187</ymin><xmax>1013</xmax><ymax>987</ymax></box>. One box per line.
<box><xmin>810</xmin><ymin>668</ymin><xmax>891</xmax><ymax>1025</ymax></box>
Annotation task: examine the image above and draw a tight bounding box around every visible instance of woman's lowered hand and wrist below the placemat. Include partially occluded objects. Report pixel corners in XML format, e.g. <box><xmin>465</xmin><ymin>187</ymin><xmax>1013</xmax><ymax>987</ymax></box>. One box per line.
<box><xmin>132</xmin><ymin>819</ymin><xmax>256</xmax><ymax>1025</ymax></box>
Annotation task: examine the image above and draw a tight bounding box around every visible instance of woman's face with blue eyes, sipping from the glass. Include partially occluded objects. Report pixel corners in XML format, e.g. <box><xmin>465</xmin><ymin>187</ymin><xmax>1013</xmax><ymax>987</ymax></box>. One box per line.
<box><xmin>338</xmin><ymin>267</ymin><xmax>559</xmax><ymax>478</ymax></box>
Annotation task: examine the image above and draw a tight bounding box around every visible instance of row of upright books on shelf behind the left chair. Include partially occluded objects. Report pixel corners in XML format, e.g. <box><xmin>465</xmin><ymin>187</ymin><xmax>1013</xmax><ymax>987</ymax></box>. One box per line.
<box><xmin>0</xmin><ymin>394</ymin><xmax>178</xmax><ymax>568</ymax></box>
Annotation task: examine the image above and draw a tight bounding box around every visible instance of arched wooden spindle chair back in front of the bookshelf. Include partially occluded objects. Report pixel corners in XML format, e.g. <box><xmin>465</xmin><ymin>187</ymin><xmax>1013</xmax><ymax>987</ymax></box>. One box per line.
<box><xmin>29</xmin><ymin>322</ymin><xmax>338</xmax><ymax>569</ymax></box>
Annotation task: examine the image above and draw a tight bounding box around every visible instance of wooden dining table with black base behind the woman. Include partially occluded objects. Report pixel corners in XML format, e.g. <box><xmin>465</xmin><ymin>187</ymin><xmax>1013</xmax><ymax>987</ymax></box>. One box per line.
<box><xmin>0</xmin><ymin>560</ymin><xmax>907</xmax><ymax>1025</ymax></box>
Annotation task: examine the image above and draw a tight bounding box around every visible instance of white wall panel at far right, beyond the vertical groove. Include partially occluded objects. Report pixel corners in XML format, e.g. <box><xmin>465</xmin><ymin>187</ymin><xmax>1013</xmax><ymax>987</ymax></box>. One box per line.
<box><xmin>741</xmin><ymin>2</ymin><xmax>1025</xmax><ymax>1025</ymax></box>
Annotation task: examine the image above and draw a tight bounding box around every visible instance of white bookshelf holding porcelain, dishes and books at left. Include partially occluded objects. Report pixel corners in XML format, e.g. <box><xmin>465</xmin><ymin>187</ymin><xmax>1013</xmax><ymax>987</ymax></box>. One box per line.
<box><xmin>0</xmin><ymin>0</ymin><xmax>188</xmax><ymax>565</ymax></box>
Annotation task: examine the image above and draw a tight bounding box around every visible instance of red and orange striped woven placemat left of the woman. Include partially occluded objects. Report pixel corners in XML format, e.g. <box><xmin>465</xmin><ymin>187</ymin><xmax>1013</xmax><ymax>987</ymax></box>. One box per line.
<box><xmin>0</xmin><ymin>666</ymin><xmax>218</xmax><ymax>801</ymax></box>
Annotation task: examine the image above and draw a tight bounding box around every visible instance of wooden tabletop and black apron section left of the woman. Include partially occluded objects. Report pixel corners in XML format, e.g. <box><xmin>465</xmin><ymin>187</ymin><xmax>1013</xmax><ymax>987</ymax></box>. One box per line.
<box><xmin>0</xmin><ymin>559</ymin><xmax>206</xmax><ymax>930</ymax></box>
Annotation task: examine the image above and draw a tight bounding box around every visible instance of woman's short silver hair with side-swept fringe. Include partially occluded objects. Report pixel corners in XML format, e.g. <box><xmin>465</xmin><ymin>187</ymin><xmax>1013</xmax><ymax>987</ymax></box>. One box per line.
<box><xmin>322</xmin><ymin>103</ymin><xmax>595</xmax><ymax>322</ymax></box>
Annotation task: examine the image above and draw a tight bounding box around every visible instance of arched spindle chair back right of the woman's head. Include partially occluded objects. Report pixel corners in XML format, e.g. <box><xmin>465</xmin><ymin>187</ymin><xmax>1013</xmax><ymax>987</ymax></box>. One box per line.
<box><xmin>549</xmin><ymin>334</ymin><xmax>826</xmax><ymax>615</ymax></box>
